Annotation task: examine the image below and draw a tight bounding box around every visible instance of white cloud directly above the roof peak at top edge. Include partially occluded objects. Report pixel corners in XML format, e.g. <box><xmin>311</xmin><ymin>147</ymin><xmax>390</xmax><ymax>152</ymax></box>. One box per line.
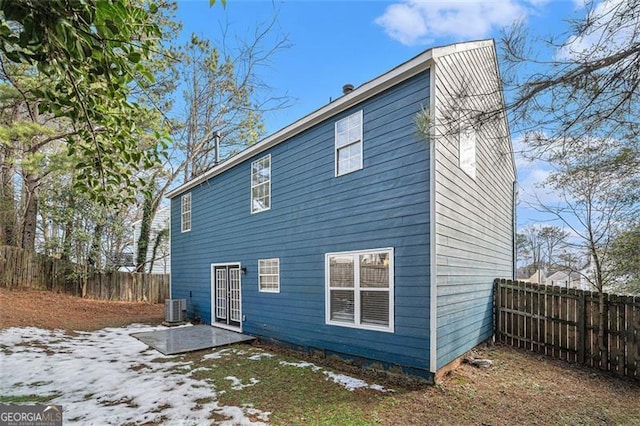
<box><xmin>375</xmin><ymin>0</ymin><xmax>528</xmax><ymax>45</ymax></box>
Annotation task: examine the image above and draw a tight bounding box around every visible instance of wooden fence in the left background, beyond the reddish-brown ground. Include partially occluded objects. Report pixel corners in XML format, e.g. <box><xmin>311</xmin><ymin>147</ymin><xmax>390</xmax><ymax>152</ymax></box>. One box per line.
<box><xmin>0</xmin><ymin>246</ymin><xmax>169</xmax><ymax>303</ymax></box>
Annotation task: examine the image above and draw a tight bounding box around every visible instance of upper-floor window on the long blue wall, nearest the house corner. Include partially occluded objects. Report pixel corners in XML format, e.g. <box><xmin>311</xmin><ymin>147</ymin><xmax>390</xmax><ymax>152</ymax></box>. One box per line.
<box><xmin>336</xmin><ymin>111</ymin><xmax>362</xmax><ymax>176</ymax></box>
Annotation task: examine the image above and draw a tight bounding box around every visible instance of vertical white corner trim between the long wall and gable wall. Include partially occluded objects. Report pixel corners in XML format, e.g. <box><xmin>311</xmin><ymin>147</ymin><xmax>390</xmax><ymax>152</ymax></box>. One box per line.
<box><xmin>429</xmin><ymin>64</ymin><xmax>438</xmax><ymax>374</ymax></box>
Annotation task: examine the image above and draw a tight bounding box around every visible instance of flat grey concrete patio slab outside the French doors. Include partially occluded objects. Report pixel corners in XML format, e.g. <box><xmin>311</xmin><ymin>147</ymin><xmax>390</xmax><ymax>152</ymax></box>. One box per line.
<box><xmin>131</xmin><ymin>325</ymin><xmax>255</xmax><ymax>355</ymax></box>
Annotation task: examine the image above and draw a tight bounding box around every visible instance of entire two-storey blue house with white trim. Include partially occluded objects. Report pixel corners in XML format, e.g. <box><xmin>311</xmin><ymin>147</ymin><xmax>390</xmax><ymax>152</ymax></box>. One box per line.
<box><xmin>169</xmin><ymin>40</ymin><xmax>516</xmax><ymax>378</ymax></box>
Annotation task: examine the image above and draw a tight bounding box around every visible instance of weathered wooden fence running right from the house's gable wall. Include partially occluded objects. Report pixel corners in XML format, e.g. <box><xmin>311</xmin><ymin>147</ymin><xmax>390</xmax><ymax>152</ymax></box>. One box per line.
<box><xmin>494</xmin><ymin>280</ymin><xmax>640</xmax><ymax>380</ymax></box>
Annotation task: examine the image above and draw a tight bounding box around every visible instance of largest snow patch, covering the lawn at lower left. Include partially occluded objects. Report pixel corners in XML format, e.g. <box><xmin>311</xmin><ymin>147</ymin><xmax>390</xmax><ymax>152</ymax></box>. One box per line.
<box><xmin>0</xmin><ymin>324</ymin><xmax>269</xmax><ymax>425</ymax></box>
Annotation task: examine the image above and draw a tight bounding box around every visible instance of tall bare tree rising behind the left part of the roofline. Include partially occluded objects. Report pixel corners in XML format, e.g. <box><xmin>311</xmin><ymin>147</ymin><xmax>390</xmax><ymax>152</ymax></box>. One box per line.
<box><xmin>136</xmin><ymin>17</ymin><xmax>288</xmax><ymax>271</ymax></box>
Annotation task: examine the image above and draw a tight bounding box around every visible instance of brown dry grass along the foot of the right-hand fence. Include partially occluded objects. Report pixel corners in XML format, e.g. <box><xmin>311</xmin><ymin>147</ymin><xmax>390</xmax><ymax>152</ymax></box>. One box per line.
<box><xmin>379</xmin><ymin>346</ymin><xmax>640</xmax><ymax>425</ymax></box>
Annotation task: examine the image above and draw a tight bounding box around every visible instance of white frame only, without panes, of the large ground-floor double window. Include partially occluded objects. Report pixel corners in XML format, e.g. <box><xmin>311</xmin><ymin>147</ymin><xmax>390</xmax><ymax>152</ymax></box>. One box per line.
<box><xmin>324</xmin><ymin>247</ymin><xmax>395</xmax><ymax>333</ymax></box>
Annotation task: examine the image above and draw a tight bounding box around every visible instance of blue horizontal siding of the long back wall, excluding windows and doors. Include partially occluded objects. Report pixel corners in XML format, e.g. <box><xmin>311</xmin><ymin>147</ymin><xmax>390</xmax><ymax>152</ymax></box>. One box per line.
<box><xmin>171</xmin><ymin>71</ymin><xmax>430</xmax><ymax>375</ymax></box>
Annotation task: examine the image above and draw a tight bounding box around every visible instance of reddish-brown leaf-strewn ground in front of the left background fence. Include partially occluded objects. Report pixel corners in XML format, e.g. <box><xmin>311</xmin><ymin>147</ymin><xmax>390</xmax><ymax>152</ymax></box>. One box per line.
<box><xmin>0</xmin><ymin>288</ymin><xmax>164</xmax><ymax>331</ymax></box>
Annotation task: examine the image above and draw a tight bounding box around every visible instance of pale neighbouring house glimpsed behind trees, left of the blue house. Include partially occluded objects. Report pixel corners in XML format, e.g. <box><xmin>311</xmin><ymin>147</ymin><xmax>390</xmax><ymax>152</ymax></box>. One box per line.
<box><xmin>132</xmin><ymin>206</ymin><xmax>171</xmax><ymax>274</ymax></box>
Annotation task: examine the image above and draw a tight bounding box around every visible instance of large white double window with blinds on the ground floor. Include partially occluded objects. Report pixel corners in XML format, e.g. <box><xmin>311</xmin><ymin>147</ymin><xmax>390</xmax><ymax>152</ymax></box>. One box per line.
<box><xmin>325</xmin><ymin>248</ymin><xmax>393</xmax><ymax>332</ymax></box>
